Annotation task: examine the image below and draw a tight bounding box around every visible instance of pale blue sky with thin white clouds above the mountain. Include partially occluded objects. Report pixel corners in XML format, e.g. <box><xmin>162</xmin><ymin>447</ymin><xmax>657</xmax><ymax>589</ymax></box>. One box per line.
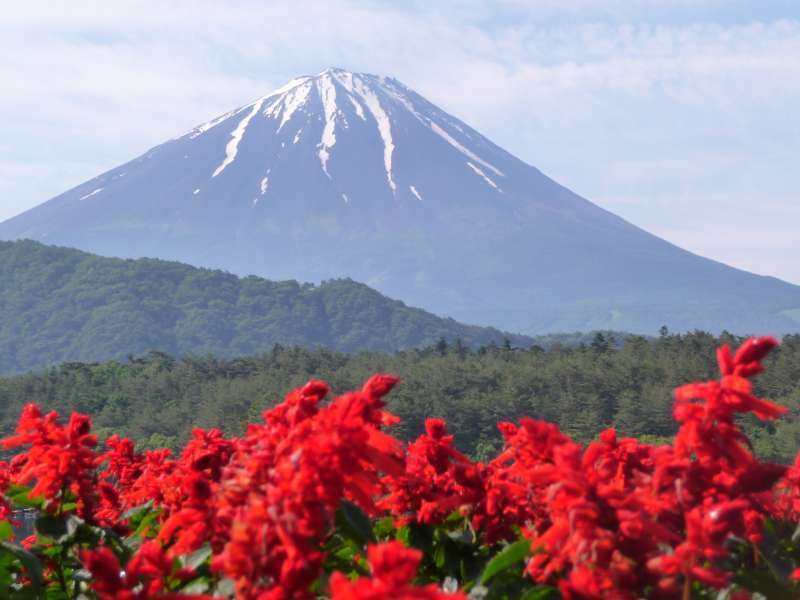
<box><xmin>0</xmin><ymin>0</ymin><xmax>800</xmax><ymax>284</ymax></box>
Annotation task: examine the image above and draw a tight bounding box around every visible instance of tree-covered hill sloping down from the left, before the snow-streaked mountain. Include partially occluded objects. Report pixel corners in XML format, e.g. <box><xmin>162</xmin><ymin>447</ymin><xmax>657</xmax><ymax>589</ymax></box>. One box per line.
<box><xmin>0</xmin><ymin>241</ymin><xmax>531</xmax><ymax>373</ymax></box>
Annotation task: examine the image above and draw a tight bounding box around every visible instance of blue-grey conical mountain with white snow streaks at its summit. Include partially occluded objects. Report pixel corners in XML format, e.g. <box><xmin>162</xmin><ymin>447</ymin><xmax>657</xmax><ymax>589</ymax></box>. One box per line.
<box><xmin>0</xmin><ymin>69</ymin><xmax>800</xmax><ymax>334</ymax></box>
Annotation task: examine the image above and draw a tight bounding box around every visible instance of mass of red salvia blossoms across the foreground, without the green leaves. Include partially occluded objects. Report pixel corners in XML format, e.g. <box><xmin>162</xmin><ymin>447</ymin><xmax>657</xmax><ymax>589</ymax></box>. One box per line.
<box><xmin>0</xmin><ymin>338</ymin><xmax>800</xmax><ymax>600</ymax></box>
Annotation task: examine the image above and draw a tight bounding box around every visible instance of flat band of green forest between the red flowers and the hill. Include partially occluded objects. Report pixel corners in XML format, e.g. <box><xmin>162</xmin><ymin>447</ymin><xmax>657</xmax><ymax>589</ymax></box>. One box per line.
<box><xmin>0</xmin><ymin>331</ymin><xmax>800</xmax><ymax>461</ymax></box>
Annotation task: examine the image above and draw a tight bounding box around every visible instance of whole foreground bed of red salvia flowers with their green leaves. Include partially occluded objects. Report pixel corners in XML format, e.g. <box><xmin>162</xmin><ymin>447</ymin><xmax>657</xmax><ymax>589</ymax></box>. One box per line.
<box><xmin>0</xmin><ymin>338</ymin><xmax>800</xmax><ymax>600</ymax></box>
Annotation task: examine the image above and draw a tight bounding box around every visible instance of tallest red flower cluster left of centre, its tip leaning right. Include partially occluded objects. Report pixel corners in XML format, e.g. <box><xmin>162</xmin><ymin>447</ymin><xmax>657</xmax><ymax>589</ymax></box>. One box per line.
<box><xmin>213</xmin><ymin>375</ymin><xmax>405</xmax><ymax>598</ymax></box>
